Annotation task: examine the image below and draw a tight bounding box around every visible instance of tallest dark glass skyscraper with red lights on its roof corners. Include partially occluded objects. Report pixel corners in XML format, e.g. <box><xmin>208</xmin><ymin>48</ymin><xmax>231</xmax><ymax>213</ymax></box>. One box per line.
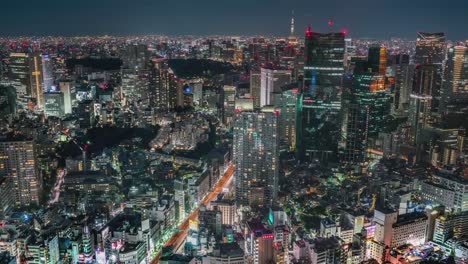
<box><xmin>296</xmin><ymin>28</ymin><xmax>345</xmax><ymax>161</ymax></box>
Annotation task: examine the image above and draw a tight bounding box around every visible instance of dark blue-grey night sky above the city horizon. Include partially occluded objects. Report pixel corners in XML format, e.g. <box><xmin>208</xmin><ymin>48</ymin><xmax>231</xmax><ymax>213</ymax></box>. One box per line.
<box><xmin>0</xmin><ymin>0</ymin><xmax>468</xmax><ymax>40</ymax></box>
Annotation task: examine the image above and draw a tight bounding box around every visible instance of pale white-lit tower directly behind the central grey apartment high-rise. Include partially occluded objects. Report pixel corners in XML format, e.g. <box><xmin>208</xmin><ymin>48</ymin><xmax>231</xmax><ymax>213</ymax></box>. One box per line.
<box><xmin>260</xmin><ymin>68</ymin><xmax>291</xmax><ymax>107</ymax></box>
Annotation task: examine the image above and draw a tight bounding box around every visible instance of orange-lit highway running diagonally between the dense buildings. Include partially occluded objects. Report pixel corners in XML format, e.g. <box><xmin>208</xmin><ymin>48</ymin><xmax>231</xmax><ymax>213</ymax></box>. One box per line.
<box><xmin>151</xmin><ymin>165</ymin><xmax>234</xmax><ymax>264</ymax></box>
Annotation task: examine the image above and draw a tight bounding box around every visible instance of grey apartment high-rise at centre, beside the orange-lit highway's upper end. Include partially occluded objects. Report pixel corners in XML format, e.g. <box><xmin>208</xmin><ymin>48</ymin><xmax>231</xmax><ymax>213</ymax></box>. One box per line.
<box><xmin>233</xmin><ymin>107</ymin><xmax>279</xmax><ymax>206</ymax></box>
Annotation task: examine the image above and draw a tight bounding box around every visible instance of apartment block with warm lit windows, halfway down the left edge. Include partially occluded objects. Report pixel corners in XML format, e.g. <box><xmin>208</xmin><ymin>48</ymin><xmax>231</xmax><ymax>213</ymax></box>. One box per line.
<box><xmin>0</xmin><ymin>138</ymin><xmax>42</xmax><ymax>206</ymax></box>
